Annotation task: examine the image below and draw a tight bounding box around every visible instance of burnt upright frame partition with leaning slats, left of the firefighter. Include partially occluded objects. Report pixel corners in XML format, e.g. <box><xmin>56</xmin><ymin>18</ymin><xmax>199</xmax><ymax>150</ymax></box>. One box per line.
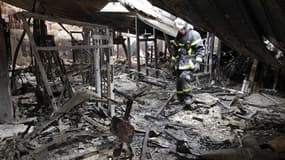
<box><xmin>12</xmin><ymin>12</ymin><xmax>113</xmax><ymax>113</ymax></box>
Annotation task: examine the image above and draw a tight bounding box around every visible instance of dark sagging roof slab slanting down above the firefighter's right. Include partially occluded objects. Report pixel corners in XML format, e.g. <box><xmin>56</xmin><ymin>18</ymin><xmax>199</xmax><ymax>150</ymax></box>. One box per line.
<box><xmin>150</xmin><ymin>0</ymin><xmax>285</xmax><ymax>67</ymax></box>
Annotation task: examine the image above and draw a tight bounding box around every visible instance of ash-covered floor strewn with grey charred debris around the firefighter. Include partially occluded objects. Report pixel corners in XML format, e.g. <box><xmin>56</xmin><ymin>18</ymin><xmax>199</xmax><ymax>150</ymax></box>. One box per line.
<box><xmin>0</xmin><ymin>63</ymin><xmax>285</xmax><ymax>160</ymax></box>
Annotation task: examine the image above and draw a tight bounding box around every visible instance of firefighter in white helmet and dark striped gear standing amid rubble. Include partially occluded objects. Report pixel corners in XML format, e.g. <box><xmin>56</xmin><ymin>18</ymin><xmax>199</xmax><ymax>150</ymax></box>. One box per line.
<box><xmin>171</xmin><ymin>18</ymin><xmax>204</xmax><ymax>105</ymax></box>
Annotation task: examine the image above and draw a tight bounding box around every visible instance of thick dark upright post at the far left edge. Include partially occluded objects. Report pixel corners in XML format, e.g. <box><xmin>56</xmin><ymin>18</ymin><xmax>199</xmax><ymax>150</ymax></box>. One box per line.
<box><xmin>0</xmin><ymin>17</ymin><xmax>13</xmax><ymax>123</ymax></box>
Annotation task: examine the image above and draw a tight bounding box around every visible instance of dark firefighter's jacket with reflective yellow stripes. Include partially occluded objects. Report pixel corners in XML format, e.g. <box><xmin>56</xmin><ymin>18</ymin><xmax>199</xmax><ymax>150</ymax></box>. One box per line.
<box><xmin>171</xmin><ymin>29</ymin><xmax>204</xmax><ymax>70</ymax></box>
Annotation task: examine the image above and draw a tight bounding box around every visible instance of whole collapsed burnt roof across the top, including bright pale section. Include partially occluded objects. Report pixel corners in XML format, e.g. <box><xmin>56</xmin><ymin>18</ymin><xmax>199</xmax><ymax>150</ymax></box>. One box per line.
<box><xmin>5</xmin><ymin>0</ymin><xmax>285</xmax><ymax>67</ymax></box>
